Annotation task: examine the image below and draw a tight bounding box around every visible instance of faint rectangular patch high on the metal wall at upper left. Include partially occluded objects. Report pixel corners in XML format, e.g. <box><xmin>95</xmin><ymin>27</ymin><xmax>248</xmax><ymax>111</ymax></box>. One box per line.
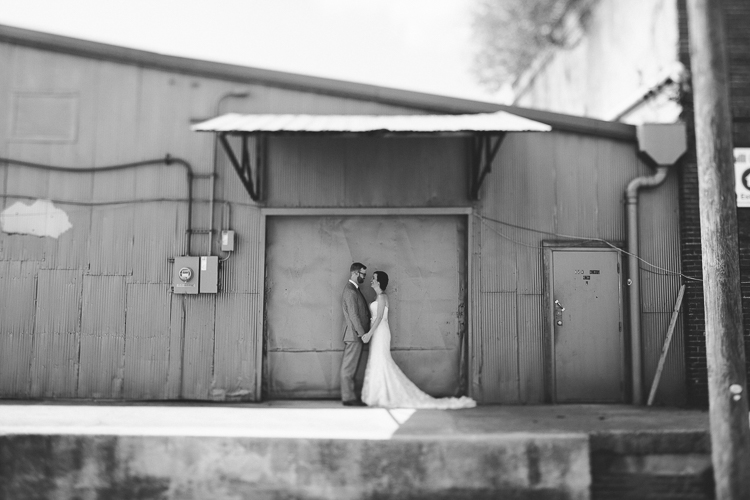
<box><xmin>11</xmin><ymin>92</ymin><xmax>78</xmax><ymax>142</ymax></box>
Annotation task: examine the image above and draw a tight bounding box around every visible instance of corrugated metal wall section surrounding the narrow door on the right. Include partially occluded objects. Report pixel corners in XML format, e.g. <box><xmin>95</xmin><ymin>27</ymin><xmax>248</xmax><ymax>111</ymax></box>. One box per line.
<box><xmin>470</xmin><ymin>133</ymin><xmax>685</xmax><ymax>404</ymax></box>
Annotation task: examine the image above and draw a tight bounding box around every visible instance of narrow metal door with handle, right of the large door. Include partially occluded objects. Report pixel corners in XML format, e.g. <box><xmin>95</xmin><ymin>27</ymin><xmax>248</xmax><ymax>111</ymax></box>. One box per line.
<box><xmin>550</xmin><ymin>249</ymin><xmax>625</xmax><ymax>403</ymax></box>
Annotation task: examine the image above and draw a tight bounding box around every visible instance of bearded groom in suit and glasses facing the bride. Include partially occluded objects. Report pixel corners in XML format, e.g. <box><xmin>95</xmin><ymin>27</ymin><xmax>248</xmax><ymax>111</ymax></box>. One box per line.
<box><xmin>341</xmin><ymin>262</ymin><xmax>370</xmax><ymax>406</ymax></box>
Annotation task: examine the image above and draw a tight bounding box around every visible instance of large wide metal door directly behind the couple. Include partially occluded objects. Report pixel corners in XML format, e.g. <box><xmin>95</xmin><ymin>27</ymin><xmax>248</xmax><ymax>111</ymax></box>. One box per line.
<box><xmin>263</xmin><ymin>215</ymin><xmax>466</xmax><ymax>399</ymax></box>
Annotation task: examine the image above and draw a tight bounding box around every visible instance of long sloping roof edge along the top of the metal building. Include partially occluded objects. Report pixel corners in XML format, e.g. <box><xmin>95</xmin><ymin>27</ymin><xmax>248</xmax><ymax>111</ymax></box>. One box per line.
<box><xmin>0</xmin><ymin>24</ymin><xmax>636</xmax><ymax>142</ymax></box>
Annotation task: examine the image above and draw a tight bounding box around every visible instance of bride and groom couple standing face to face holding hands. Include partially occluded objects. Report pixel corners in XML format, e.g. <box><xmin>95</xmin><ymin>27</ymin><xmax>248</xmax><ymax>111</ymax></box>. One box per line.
<box><xmin>341</xmin><ymin>262</ymin><xmax>476</xmax><ymax>409</ymax></box>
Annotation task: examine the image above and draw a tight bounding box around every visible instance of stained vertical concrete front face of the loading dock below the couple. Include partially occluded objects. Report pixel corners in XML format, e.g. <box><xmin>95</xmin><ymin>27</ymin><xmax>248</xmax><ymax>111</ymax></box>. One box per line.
<box><xmin>0</xmin><ymin>434</ymin><xmax>591</xmax><ymax>500</ymax></box>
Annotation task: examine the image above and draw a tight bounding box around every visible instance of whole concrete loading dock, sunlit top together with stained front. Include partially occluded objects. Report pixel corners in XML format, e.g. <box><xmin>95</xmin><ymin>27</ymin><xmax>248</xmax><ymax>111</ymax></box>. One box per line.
<box><xmin>0</xmin><ymin>400</ymin><xmax>710</xmax><ymax>500</ymax></box>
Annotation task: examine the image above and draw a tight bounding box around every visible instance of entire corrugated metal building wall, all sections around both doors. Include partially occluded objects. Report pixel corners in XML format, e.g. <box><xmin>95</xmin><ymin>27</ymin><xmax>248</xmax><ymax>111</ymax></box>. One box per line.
<box><xmin>0</xmin><ymin>38</ymin><xmax>684</xmax><ymax>403</ymax></box>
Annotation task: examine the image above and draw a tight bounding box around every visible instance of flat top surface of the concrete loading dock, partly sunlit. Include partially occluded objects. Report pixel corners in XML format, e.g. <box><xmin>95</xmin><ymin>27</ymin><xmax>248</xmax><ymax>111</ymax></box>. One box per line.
<box><xmin>0</xmin><ymin>400</ymin><xmax>708</xmax><ymax>440</ymax></box>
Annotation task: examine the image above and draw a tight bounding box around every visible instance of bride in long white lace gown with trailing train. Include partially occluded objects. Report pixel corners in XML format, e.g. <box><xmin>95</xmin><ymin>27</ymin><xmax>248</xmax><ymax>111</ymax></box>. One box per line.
<box><xmin>362</xmin><ymin>271</ymin><xmax>477</xmax><ymax>410</ymax></box>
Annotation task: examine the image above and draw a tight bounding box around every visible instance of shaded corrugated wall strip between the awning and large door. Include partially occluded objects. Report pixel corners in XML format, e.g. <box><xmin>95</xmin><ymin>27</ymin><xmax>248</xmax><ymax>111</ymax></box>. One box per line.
<box><xmin>267</xmin><ymin>137</ymin><xmax>468</xmax><ymax>207</ymax></box>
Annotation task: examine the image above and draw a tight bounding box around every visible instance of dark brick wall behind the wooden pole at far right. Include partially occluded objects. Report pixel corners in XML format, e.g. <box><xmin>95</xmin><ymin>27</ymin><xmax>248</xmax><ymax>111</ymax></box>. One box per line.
<box><xmin>678</xmin><ymin>0</ymin><xmax>750</xmax><ymax>406</ymax></box>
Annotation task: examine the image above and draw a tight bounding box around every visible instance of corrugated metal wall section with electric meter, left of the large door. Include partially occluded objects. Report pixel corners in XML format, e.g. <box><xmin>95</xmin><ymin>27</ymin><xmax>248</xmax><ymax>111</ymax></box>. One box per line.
<box><xmin>0</xmin><ymin>39</ymin><xmax>421</xmax><ymax>400</ymax></box>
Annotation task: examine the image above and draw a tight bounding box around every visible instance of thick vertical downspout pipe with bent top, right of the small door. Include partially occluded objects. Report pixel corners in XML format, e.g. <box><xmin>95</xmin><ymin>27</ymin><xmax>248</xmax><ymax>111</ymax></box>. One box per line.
<box><xmin>625</xmin><ymin>166</ymin><xmax>669</xmax><ymax>405</ymax></box>
